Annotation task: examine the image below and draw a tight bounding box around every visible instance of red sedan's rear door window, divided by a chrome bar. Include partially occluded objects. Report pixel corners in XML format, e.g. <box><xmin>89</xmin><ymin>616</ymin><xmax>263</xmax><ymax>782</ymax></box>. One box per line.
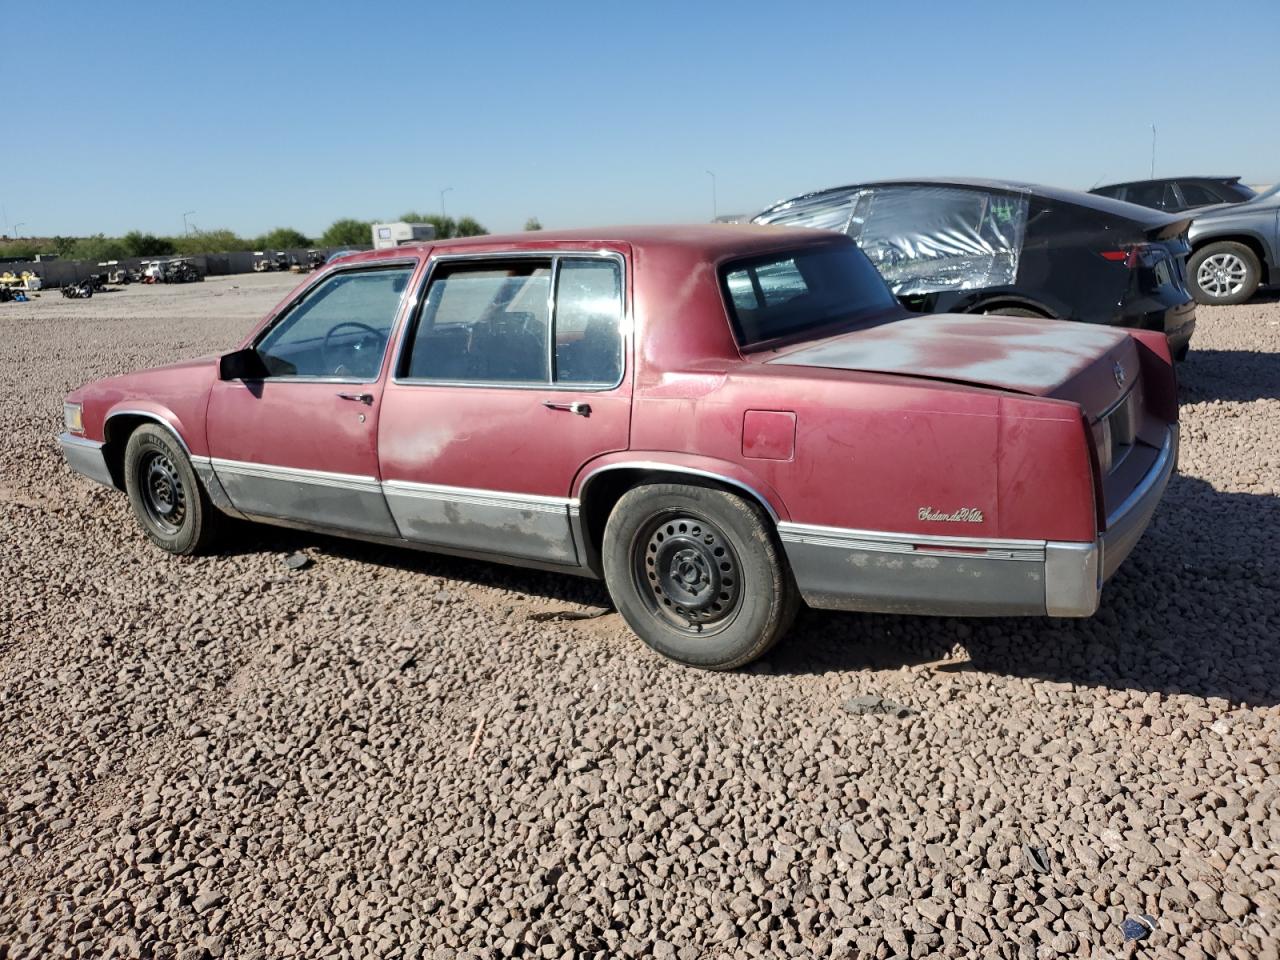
<box><xmin>401</xmin><ymin>257</ymin><xmax>622</xmax><ymax>387</ymax></box>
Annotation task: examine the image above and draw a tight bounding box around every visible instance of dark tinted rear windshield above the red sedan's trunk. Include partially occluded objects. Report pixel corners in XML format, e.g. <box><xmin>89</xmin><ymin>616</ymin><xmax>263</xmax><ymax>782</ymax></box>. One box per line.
<box><xmin>721</xmin><ymin>243</ymin><xmax>897</xmax><ymax>347</ymax></box>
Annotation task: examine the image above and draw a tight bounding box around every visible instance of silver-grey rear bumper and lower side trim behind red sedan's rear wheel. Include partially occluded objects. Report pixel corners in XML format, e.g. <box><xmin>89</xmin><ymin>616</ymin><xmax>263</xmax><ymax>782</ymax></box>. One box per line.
<box><xmin>778</xmin><ymin>425</ymin><xmax>1178</xmax><ymax>617</ymax></box>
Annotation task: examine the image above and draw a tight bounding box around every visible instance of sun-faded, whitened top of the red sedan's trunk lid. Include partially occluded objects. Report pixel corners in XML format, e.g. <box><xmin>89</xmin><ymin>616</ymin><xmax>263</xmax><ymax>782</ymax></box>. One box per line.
<box><xmin>768</xmin><ymin>314</ymin><xmax>1139</xmax><ymax>416</ymax></box>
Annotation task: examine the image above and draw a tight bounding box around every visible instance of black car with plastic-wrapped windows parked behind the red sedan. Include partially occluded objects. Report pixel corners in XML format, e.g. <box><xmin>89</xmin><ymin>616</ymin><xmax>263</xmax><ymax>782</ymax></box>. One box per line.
<box><xmin>753</xmin><ymin>179</ymin><xmax>1196</xmax><ymax>360</ymax></box>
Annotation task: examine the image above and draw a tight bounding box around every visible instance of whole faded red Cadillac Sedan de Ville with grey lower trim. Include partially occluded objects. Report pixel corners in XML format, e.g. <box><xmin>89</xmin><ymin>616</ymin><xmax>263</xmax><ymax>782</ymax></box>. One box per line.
<box><xmin>60</xmin><ymin>225</ymin><xmax>1178</xmax><ymax>668</ymax></box>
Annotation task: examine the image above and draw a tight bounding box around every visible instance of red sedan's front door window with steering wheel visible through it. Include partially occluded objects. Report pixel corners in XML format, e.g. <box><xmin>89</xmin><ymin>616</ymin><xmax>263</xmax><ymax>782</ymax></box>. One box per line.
<box><xmin>255</xmin><ymin>265</ymin><xmax>413</xmax><ymax>380</ymax></box>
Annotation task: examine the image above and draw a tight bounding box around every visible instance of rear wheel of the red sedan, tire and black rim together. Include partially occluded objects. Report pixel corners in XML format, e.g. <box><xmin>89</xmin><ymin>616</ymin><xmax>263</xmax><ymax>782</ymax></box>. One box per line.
<box><xmin>603</xmin><ymin>484</ymin><xmax>800</xmax><ymax>669</ymax></box>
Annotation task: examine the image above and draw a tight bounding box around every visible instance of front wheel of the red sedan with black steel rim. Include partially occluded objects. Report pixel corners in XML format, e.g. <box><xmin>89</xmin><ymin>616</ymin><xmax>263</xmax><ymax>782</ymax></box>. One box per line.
<box><xmin>124</xmin><ymin>424</ymin><xmax>221</xmax><ymax>557</ymax></box>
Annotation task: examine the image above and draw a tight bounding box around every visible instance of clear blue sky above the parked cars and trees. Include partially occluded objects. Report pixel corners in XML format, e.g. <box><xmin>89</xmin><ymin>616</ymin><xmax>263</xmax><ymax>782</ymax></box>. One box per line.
<box><xmin>0</xmin><ymin>0</ymin><xmax>1280</xmax><ymax>236</ymax></box>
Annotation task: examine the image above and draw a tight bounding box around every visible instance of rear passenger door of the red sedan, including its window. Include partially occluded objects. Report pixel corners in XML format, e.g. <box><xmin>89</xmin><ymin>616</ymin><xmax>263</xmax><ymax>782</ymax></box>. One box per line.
<box><xmin>379</xmin><ymin>253</ymin><xmax>631</xmax><ymax>564</ymax></box>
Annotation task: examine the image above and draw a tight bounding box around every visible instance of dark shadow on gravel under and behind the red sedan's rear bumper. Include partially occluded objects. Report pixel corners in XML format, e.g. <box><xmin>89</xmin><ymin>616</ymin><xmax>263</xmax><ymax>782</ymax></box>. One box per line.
<box><xmin>772</xmin><ymin>476</ymin><xmax>1280</xmax><ymax>707</ymax></box>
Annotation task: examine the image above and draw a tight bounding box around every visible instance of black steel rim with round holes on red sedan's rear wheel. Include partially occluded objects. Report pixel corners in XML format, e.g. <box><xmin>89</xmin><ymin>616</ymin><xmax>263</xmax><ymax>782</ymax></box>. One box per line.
<box><xmin>632</xmin><ymin>512</ymin><xmax>742</xmax><ymax>636</ymax></box>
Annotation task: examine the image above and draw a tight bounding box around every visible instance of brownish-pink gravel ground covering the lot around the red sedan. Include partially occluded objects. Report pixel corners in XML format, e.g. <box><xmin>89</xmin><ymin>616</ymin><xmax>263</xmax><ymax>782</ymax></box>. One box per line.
<box><xmin>0</xmin><ymin>276</ymin><xmax>1280</xmax><ymax>960</ymax></box>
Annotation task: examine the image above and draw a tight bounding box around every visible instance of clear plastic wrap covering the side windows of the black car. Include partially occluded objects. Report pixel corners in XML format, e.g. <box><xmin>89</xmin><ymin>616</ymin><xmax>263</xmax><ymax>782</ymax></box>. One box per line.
<box><xmin>756</xmin><ymin>186</ymin><xmax>1029</xmax><ymax>297</ymax></box>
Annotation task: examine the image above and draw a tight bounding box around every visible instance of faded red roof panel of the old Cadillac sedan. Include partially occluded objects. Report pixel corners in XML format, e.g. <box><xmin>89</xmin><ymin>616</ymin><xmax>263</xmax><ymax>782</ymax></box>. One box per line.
<box><xmin>325</xmin><ymin>223</ymin><xmax>849</xmax><ymax>262</ymax></box>
